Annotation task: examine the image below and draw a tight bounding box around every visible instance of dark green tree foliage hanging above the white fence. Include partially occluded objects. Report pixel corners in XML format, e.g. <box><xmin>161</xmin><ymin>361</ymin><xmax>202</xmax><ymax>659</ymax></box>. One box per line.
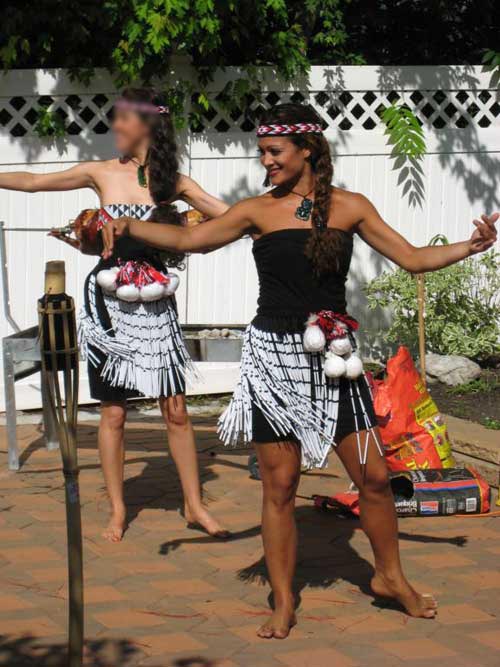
<box><xmin>0</xmin><ymin>0</ymin><xmax>500</xmax><ymax>78</ymax></box>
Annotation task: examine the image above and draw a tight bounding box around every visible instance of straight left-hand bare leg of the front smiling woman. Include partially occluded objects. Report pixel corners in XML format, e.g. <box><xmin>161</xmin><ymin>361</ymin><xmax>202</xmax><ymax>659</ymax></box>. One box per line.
<box><xmin>256</xmin><ymin>442</ymin><xmax>300</xmax><ymax>639</ymax></box>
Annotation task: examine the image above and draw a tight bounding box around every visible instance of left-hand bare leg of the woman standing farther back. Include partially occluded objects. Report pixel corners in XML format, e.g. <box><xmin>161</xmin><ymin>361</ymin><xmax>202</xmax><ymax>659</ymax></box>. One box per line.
<box><xmin>97</xmin><ymin>403</ymin><xmax>127</xmax><ymax>542</ymax></box>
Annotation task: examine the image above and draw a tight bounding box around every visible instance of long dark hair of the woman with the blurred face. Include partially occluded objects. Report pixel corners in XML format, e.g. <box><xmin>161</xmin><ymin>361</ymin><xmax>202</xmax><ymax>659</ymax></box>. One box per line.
<box><xmin>121</xmin><ymin>88</ymin><xmax>185</xmax><ymax>269</ymax></box>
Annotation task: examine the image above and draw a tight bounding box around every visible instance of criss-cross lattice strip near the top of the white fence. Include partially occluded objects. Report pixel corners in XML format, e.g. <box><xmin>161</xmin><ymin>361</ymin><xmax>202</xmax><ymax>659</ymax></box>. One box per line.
<box><xmin>0</xmin><ymin>90</ymin><xmax>500</xmax><ymax>137</ymax></box>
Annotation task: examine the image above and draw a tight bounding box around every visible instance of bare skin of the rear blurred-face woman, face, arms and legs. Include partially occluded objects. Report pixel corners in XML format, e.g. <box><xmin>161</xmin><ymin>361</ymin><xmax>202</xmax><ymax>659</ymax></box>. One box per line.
<box><xmin>0</xmin><ymin>111</ymin><xmax>228</xmax><ymax>542</ymax></box>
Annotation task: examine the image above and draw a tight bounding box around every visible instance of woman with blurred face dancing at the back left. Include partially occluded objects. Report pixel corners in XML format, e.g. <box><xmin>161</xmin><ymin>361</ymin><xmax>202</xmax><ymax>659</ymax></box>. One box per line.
<box><xmin>0</xmin><ymin>89</ymin><xmax>228</xmax><ymax>542</ymax></box>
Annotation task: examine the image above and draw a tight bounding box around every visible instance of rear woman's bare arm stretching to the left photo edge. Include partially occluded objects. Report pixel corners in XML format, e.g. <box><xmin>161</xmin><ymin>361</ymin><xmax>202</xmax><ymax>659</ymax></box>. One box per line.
<box><xmin>0</xmin><ymin>162</ymin><xmax>96</xmax><ymax>192</ymax></box>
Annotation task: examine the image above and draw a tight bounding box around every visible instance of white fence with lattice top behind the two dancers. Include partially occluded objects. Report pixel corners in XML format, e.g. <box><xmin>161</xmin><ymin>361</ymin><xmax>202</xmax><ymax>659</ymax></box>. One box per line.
<box><xmin>0</xmin><ymin>67</ymin><xmax>500</xmax><ymax>408</ymax></box>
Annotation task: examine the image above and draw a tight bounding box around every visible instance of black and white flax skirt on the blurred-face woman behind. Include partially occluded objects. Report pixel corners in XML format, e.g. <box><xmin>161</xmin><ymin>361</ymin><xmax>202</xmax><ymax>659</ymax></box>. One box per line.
<box><xmin>79</xmin><ymin>265</ymin><xmax>195</xmax><ymax>401</ymax></box>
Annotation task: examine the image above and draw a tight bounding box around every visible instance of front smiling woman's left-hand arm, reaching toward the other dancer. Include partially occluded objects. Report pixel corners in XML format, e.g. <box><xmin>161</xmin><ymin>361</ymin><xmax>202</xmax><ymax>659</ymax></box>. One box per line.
<box><xmin>102</xmin><ymin>200</ymin><xmax>252</xmax><ymax>258</ymax></box>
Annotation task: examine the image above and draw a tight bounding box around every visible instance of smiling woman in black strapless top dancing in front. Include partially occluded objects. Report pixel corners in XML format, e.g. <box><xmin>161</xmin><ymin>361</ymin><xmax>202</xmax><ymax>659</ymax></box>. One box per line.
<box><xmin>104</xmin><ymin>104</ymin><xmax>498</xmax><ymax>639</ymax></box>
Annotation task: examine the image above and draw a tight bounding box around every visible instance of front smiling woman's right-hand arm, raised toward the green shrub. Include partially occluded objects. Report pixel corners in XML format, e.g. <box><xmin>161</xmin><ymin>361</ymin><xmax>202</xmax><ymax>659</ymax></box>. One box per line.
<box><xmin>354</xmin><ymin>195</ymin><xmax>499</xmax><ymax>273</ymax></box>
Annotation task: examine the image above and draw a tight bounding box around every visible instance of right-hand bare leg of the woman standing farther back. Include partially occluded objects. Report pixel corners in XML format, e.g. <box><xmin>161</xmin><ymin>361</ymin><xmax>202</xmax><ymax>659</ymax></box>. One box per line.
<box><xmin>160</xmin><ymin>395</ymin><xmax>230</xmax><ymax>539</ymax></box>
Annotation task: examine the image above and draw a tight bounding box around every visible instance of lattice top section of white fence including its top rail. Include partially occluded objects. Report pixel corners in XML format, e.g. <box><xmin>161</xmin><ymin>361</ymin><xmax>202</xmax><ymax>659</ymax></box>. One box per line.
<box><xmin>0</xmin><ymin>67</ymin><xmax>500</xmax><ymax>137</ymax></box>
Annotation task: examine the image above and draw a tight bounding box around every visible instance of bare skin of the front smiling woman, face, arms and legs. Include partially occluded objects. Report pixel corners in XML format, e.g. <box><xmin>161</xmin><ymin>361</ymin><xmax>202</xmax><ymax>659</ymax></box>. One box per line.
<box><xmin>104</xmin><ymin>137</ymin><xmax>499</xmax><ymax>639</ymax></box>
